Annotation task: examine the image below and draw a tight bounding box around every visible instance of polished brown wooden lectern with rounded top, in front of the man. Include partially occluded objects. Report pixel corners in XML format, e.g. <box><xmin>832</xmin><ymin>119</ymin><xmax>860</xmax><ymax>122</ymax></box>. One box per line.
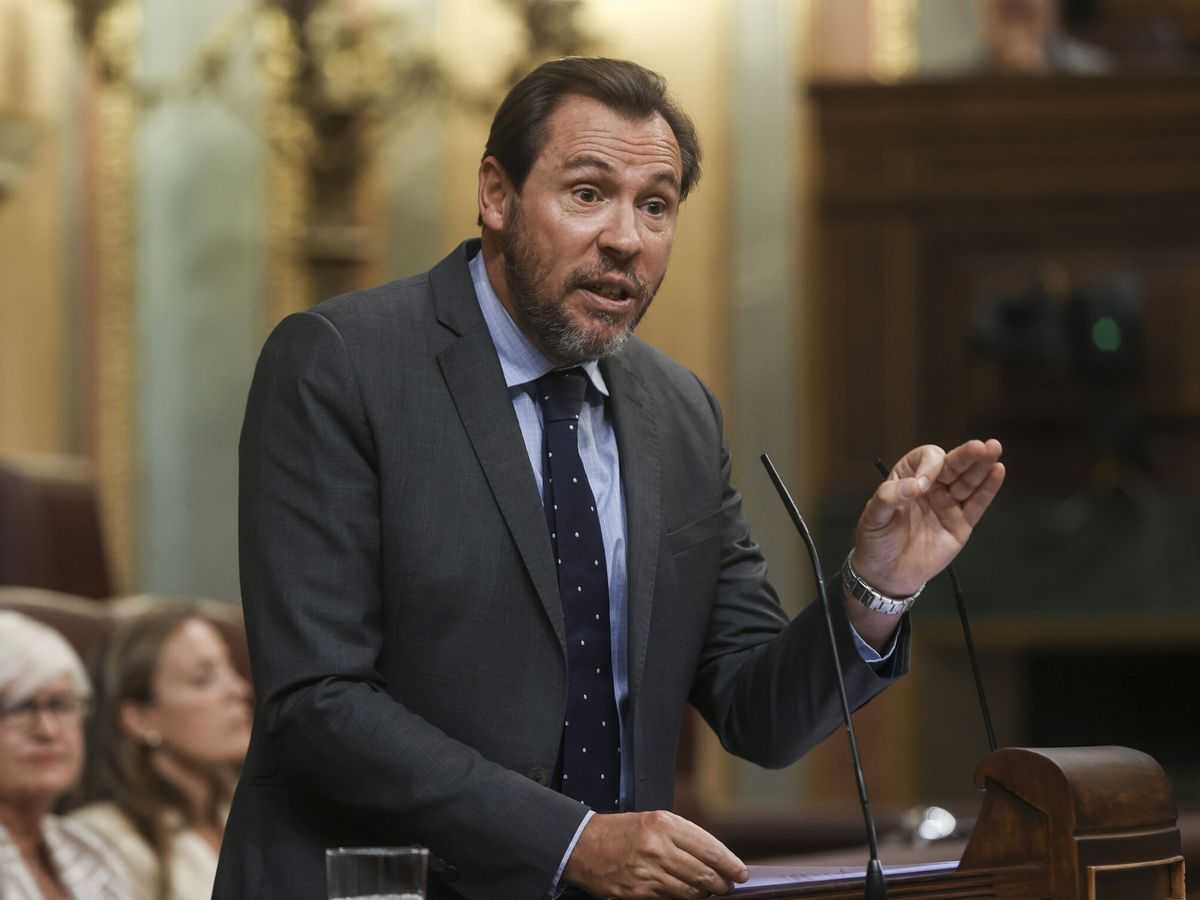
<box><xmin>736</xmin><ymin>746</ymin><xmax>1186</xmax><ymax>900</ymax></box>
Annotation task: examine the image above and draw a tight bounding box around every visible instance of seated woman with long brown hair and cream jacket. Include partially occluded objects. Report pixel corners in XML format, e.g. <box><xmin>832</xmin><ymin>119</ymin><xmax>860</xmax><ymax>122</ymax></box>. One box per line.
<box><xmin>72</xmin><ymin>601</ymin><xmax>251</xmax><ymax>900</ymax></box>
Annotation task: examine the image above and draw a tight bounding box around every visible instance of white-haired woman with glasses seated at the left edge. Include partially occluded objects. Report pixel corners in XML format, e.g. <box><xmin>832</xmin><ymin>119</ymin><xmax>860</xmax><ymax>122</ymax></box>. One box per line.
<box><xmin>0</xmin><ymin>612</ymin><xmax>130</xmax><ymax>900</ymax></box>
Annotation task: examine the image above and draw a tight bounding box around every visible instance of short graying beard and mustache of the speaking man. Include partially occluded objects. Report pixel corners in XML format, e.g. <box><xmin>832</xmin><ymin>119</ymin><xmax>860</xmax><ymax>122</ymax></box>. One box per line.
<box><xmin>500</xmin><ymin>202</ymin><xmax>658</xmax><ymax>366</ymax></box>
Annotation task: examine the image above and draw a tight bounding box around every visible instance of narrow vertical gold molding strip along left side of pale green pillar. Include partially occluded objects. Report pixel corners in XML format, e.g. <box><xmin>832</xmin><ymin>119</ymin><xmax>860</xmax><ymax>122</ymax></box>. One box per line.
<box><xmin>90</xmin><ymin>0</ymin><xmax>142</xmax><ymax>593</ymax></box>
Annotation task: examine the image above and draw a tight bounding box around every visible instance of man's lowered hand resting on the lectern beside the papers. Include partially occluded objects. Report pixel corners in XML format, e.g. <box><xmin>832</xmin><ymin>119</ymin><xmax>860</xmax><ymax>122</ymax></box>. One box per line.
<box><xmin>564</xmin><ymin>810</ymin><xmax>749</xmax><ymax>900</ymax></box>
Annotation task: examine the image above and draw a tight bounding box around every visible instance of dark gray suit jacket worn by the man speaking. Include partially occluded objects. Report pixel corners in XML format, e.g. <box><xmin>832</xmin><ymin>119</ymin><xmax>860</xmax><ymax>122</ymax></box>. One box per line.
<box><xmin>215</xmin><ymin>241</ymin><xmax>907</xmax><ymax>900</ymax></box>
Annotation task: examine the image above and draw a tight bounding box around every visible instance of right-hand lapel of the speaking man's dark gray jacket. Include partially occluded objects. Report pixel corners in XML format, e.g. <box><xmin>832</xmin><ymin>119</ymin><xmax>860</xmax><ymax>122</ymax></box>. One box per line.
<box><xmin>601</xmin><ymin>354</ymin><xmax>662</xmax><ymax>703</ymax></box>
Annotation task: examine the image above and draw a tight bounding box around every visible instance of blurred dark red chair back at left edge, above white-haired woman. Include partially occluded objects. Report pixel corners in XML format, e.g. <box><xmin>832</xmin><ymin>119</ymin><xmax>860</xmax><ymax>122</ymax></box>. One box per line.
<box><xmin>0</xmin><ymin>456</ymin><xmax>113</xmax><ymax>598</ymax></box>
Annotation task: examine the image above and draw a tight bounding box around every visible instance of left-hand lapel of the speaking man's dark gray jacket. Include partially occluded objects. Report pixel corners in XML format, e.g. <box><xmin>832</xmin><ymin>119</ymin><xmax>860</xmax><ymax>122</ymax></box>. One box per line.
<box><xmin>430</xmin><ymin>247</ymin><xmax>566</xmax><ymax>656</ymax></box>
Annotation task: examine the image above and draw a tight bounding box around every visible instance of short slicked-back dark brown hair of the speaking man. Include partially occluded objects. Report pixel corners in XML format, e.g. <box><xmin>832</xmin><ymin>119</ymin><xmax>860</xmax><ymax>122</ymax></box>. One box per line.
<box><xmin>484</xmin><ymin>56</ymin><xmax>700</xmax><ymax>199</ymax></box>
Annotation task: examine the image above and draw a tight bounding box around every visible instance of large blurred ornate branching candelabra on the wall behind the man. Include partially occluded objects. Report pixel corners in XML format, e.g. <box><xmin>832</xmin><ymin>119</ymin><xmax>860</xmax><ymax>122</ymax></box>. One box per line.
<box><xmin>70</xmin><ymin>0</ymin><xmax>593</xmax><ymax>324</ymax></box>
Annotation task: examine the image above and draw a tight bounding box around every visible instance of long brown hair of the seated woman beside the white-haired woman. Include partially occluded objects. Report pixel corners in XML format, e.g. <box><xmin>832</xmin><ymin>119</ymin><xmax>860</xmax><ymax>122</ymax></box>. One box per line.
<box><xmin>82</xmin><ymin>600</ymin><xmax>236</xmax><ymax>899</ymax></box>
